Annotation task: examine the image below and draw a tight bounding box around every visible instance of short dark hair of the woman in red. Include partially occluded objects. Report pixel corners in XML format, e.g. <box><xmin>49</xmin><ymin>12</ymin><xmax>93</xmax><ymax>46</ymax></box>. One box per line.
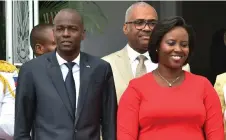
<box><xmin>148</xmin><ymin>16</ymin><xmax>195</xmax><ymax>65</ymax></box>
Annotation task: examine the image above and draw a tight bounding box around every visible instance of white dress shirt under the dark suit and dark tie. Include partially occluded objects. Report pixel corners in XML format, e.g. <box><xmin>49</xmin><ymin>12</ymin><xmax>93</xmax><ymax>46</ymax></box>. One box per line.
<box><xmin>56</xmin><ymin>52</ymin><xmax>80</xmax><ymax>108</ymax></box>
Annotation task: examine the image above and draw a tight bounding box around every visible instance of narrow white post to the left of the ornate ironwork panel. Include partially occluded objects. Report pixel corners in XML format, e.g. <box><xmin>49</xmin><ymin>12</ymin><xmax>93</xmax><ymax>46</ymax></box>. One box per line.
<box><xmin>5</xmin><ymin>0</ymin><xmax>13</xmax><ymax>63</ymax></box>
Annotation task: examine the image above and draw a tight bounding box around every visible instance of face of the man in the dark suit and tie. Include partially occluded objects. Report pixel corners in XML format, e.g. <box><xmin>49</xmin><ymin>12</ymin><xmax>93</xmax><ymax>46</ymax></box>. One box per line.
<box><xmin>53</xmin><ymin>11</ymin><xmax>84</xmax><ymax>54</ymax></box>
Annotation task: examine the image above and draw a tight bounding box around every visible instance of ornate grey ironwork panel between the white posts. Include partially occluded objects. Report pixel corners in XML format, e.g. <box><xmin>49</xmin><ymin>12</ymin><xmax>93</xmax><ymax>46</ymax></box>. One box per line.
<box><xmin>12</xmin><ymin>1</ymin><xmax>32</xmax><ymax>63</ymax></box>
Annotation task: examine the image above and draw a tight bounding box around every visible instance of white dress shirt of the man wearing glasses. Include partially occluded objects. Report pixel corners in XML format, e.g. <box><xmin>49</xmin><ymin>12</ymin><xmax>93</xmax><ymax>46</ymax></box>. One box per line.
<box><xmin>126</xmin><ymin>44</ymin><xmax>158</xmax><ymax>77</ymax></box>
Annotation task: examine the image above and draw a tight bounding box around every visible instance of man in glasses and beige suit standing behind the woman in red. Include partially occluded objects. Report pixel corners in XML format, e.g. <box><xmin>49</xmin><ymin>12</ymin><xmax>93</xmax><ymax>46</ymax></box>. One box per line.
<box><xmin>103</xmin><ymin>2</ymin><xmax>189</xmax><ymax>101</ymax></box>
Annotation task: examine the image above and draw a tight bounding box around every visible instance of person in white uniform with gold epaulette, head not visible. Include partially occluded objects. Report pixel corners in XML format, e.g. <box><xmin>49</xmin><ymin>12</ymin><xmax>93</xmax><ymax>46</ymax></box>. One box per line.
<box><xmin>0</xmin><ymin>60</ymin><xmax>18</xmax><ymax>140</ymax></box>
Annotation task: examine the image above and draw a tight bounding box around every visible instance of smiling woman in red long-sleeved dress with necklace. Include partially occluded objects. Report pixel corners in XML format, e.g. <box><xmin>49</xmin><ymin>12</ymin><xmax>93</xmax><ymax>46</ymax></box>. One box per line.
<box><xmin>117</xmin><ymin>17</ymin><xmax>224</xmax><ymax>140</ymax></box>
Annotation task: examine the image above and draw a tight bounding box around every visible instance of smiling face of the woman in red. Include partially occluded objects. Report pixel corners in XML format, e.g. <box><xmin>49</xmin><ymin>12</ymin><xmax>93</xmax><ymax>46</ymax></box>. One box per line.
<box><xmin>157</xmin><ymin>27</ymin><xmax>189</xmax><ymax>69</ymax></box>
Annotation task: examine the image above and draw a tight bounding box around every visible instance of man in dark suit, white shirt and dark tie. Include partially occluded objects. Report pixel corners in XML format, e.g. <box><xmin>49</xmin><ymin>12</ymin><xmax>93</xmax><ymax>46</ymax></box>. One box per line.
<box><xmin>14</xmin><ymin>9</ymin><xmax>117</xmax><ymax>140</ymax></box>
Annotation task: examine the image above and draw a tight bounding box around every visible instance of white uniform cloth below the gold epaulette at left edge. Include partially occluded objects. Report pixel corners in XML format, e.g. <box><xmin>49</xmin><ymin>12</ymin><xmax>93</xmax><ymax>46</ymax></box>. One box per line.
<box><xmin>0</xmin><ymin>72</ymin><xmax>18</xmax><ymax>140</ymax></box>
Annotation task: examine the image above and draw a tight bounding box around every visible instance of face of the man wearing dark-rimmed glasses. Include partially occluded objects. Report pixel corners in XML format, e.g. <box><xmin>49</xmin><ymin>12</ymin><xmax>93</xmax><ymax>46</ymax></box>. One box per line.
<box><xmin>123</xmin><ymin>6</ymin><xmax>158</xmax><ymax>53</ymax></box>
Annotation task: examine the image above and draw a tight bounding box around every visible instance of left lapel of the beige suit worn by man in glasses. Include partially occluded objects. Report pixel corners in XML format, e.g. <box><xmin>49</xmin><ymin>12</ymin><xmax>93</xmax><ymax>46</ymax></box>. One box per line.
<box><xmin>115</xmin><ymin>47</ymin><xmax>133</xmax><ymax>85</ymax></box>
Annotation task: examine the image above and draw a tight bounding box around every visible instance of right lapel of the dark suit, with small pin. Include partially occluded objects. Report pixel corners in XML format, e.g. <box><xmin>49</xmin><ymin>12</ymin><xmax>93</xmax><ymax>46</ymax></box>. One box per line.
<box><xmin>75</xmin><ymin>52</ymin><xmax>92</xmax><ymax>125</ymax></box>
